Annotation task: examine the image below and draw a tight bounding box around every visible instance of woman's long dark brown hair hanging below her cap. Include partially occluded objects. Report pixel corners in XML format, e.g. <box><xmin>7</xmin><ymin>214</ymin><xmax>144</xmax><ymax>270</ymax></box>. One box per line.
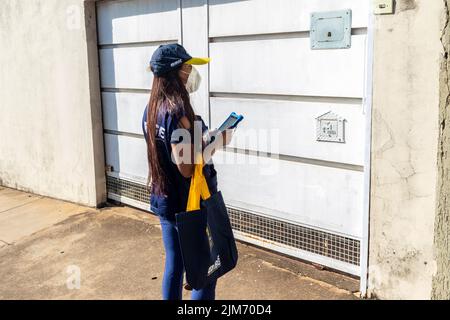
<box><xmin>147</xmin><ymin>70</ymin><xmax>195</xmax><ymax>195</ymax></box>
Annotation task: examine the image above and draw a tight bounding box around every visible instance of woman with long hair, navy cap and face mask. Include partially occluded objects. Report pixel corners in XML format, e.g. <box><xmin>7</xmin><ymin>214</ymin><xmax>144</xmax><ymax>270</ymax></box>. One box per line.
<box><xmin>143</xmin><ymin>44</ymin><xmax>231</xmax><ymax>300</ymax></box>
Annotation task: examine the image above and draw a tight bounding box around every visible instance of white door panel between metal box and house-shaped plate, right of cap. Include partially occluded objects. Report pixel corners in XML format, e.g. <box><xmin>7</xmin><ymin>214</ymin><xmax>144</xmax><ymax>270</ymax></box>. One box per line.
<box><xmin>210</xmin><ymin>35</ymin><xmax>366</xmax><ymax>97</ymax></box>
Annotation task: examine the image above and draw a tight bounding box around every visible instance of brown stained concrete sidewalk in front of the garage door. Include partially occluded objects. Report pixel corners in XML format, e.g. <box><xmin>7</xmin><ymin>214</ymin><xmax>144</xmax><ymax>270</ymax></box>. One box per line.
<box><xmin>0</xmin><ymin>187</ymin><xmax>359</xmax><ymax>300</ymax></box>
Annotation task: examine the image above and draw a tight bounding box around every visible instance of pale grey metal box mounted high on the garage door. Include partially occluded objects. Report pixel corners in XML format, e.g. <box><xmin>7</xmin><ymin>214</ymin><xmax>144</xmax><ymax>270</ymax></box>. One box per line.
<box><xmin>310</xmin><ymin>9</ymin><xmax>352</xmax><ymax>50</ymax></box>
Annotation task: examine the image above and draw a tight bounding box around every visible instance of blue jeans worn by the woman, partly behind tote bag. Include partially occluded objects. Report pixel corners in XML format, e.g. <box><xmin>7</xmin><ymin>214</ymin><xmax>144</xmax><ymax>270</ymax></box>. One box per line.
<box><xmin>159</xmin><ymin>217</ymin><xmax>216</xmax><ymax>300</ymax></box>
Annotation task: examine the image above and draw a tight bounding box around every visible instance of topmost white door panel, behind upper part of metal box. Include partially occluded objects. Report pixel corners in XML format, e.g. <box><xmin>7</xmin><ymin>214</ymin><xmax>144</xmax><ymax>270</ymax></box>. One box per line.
<box><xmin>209</xmin><ymin>0</ymin><xmax>369</xmax><ymax>37</ymax></box>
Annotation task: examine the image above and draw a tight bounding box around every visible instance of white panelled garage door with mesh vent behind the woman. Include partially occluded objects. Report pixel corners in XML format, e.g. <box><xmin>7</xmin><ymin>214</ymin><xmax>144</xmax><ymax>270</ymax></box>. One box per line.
<box><xmin>97</xmin><ymin>0</ymin><xmax>369</xmax><ymax>275</ymax></box>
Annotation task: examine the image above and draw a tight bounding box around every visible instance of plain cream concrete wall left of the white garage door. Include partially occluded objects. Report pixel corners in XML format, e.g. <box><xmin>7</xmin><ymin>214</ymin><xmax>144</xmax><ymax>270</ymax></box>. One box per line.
<box><xmin>0</xmin><ymin>0</ymin><xmax>106</xmax><ymax>206</ymax></box>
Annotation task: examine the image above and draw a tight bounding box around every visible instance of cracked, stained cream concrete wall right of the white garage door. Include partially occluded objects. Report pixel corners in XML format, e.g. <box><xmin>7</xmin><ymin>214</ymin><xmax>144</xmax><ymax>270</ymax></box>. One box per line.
<box><xmin>368</xmin><ymin>0</ymin><xmax>444</xmax><ymax>299</ymax></box>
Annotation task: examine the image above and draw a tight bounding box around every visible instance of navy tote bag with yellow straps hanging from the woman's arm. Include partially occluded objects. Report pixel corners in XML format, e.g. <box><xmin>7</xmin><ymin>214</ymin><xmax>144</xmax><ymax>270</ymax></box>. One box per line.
<box><xmin>175</xmin><ymin>164</ymin><xmax>238</xmax><ymax>290</ymax></box>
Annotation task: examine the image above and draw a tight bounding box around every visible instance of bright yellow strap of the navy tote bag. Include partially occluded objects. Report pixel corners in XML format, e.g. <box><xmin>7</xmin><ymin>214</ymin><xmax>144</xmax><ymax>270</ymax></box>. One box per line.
<box><xmin>186</xmin><ymin>154</ymin><xmax>211</xmax><ymax>211</ymax></box>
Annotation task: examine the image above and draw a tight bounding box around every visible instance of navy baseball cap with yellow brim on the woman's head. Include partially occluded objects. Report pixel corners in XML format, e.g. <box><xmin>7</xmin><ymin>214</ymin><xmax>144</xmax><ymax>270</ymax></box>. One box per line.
<box><xmin>150</xmin><ymin>43</ymin><xmax>210</xmax><ymax>77</ymax></box>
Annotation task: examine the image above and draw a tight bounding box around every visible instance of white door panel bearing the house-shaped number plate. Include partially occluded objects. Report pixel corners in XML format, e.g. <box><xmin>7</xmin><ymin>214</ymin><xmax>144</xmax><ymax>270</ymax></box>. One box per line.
<box><xmin>211</xmin><ymin>97</ymin><xmax>365</xmax><ymax>166</ymax></box>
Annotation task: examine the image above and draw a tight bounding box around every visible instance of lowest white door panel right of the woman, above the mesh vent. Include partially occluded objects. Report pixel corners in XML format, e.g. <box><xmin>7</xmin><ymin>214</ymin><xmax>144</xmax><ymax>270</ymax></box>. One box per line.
<box><xmin>215</xmin><ymin>152</ymin><xmax>364</xmax><ymax>237</ymax></box>
